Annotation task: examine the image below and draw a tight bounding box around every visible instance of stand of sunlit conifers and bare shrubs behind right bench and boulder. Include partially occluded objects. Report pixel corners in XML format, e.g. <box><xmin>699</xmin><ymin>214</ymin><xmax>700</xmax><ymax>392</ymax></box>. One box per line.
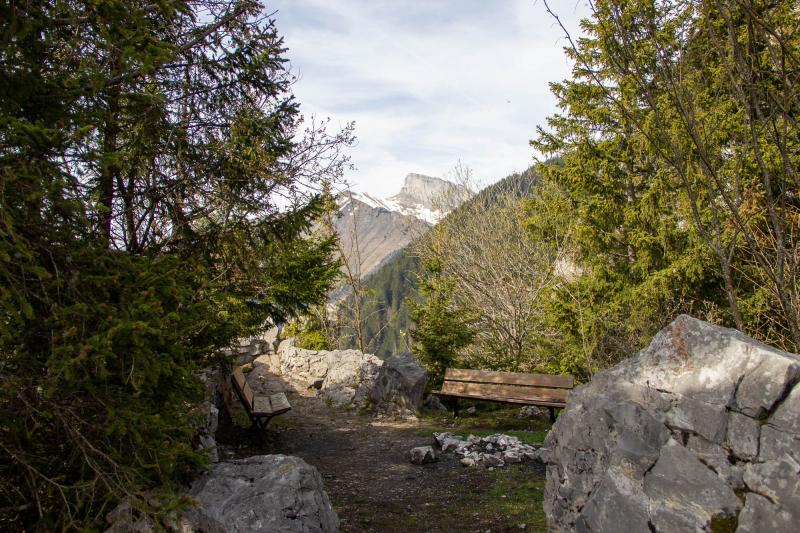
<box><xmin>414</xmin><ymin>1</ymin><xmax>800</xmax><ymax>379</ymax></box>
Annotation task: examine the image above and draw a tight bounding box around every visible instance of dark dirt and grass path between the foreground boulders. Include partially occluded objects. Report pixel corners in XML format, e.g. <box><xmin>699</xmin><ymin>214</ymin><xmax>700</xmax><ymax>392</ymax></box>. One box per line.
<box><xmin>221</xmin><ymin>393</ymin><xmax>544</xmax><ymax>533</ymax></box>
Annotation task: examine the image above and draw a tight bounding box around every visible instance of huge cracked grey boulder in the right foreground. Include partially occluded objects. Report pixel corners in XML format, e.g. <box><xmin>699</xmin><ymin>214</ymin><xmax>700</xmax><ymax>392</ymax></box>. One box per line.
<box><xmin>542</xmin><ymin>315</ymin><xmax>800</xmax><ymax>532</ymax></box>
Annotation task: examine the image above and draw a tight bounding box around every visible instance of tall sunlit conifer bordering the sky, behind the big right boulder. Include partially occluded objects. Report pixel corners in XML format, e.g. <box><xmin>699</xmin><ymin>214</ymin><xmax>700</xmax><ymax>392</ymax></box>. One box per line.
<box><xmin>532</xmin><ymin>2</ymin><xmax>730</xmax><ymax>371</ymax></box>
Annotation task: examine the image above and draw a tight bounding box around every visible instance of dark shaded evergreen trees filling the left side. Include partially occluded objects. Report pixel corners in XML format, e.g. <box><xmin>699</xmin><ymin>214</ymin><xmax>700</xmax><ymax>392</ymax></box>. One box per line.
<box><xmin>0</xmin><ymin>0</ymin><xmax>350</xmax><ymax>531</ymax></box>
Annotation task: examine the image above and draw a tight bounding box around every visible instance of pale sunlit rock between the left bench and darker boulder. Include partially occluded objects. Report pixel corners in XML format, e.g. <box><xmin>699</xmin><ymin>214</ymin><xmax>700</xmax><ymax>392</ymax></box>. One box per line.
<box><xmin>277</xmin><ymin>339</ymin><xmax>383</xmax><ymax>406</ymax></box>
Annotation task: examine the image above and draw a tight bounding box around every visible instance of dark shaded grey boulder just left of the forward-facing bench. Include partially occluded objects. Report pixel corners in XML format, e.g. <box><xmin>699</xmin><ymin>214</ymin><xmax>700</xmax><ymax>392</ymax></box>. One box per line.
<box><xmin>369</xmin><ymin>355</ymin><xmax>428</xmax><ymax>414</ymax></box>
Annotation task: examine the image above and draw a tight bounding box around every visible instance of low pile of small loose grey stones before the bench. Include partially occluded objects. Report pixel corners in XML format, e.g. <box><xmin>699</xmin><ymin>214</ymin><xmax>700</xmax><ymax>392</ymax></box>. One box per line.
<box><xmin>411</xmin><ymin>432</ymin><xmax>540</xmax><ymax>468</ymax></box>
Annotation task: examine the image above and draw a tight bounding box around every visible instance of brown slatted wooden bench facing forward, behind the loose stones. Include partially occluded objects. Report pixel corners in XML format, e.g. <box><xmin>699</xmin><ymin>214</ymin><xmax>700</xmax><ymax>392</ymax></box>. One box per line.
<box><xmin>433</xmin><ymin>368</ymin><xmax>575</xmax><ymax>422</ymax></box>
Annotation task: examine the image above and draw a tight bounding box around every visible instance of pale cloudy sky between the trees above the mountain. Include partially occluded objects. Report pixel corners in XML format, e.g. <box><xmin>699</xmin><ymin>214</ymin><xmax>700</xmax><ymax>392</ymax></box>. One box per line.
<box><xmin>269</xmin><ymin>0</ymin><xmax>587</xmax><ymax>196</ymax></box>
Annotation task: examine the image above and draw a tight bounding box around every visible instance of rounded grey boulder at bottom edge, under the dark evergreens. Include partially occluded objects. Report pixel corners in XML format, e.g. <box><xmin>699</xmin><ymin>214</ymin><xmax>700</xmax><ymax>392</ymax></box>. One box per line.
<box><xmin>182</xmin><ymin>455</ymin><xmax>339</xmax><ymax>533</ymax></box>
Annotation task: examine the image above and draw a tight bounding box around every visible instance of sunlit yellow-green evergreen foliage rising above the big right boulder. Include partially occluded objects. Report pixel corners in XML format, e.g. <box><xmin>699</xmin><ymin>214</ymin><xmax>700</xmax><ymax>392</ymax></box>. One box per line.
<box><xmin>533</xmin><ymin>0</ymin><xmax>800</xmax><ymax>374</ymax></box>
